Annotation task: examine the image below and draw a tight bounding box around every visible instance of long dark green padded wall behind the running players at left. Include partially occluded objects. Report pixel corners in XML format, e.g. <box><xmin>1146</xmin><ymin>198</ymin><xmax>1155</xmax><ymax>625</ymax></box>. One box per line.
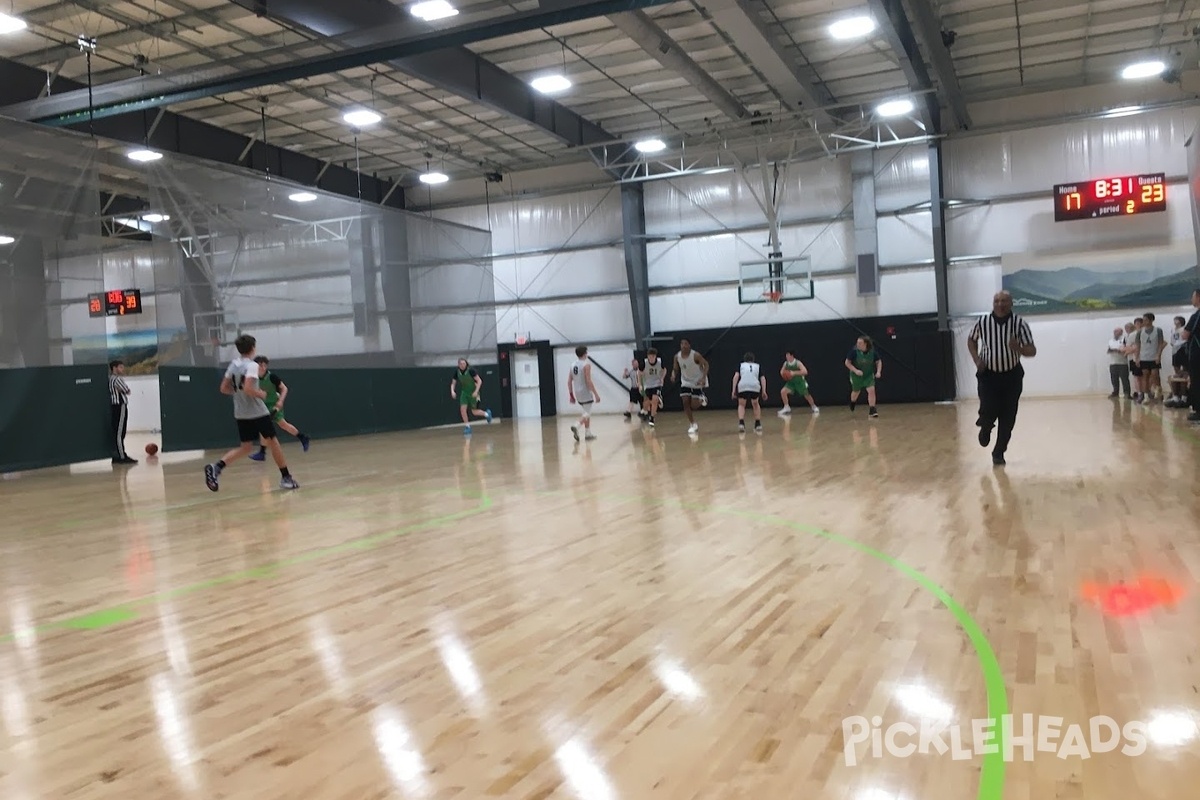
<box><xmin>158</xmin><ymin>363</ymin><xmax>500</xmax><ymax>452</ymax></box>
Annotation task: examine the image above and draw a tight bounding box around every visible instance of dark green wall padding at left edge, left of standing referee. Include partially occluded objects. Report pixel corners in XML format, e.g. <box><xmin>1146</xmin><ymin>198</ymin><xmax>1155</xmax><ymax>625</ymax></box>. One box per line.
<box><xmin>0</xmin><ymin>365</ymin><xmax>114</xmax><ymax>473</ymax></box>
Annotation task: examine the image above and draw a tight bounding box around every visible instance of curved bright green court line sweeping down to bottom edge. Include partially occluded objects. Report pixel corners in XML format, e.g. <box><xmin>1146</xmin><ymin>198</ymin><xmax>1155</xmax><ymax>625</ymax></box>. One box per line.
<box><xmin>541</xmin><ymin>489</ymin><xmax>1008</xmax><ymax>800</ymax></box>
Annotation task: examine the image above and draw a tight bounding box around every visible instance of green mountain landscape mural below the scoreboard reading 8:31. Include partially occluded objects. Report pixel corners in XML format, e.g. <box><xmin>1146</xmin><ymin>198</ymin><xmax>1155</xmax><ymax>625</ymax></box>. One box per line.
<box><xmin>1002</xmin><ymin>265</ymin><xmax>1200</xmax><ymax>314</ymax></box>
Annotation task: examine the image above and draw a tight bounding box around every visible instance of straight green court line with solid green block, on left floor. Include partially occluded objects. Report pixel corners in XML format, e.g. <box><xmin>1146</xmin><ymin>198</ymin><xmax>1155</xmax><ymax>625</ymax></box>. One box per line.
<box><xmin>0</xmin><ymin>487</ymin><xmax>492</xmax><ymax>644</ymax></box>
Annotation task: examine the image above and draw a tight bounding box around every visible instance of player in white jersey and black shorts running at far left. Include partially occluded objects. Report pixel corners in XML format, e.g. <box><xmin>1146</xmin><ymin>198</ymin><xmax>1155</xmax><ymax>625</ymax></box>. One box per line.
<box><xmin>204</xmin><ymin>333</ymin><xmax>300</xmax><ymax>492</ymax></box>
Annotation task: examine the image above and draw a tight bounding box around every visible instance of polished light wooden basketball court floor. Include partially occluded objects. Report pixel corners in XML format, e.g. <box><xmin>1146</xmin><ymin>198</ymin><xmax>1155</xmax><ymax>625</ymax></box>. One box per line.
<box><xmin>0</xmin><ymin>399</ymin><xmax>1200</xmax><ymax>800</ymax></box>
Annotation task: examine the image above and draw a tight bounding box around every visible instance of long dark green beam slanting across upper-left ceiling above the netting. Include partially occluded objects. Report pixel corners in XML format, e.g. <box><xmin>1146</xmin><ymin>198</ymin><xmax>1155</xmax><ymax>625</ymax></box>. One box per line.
<box><xmin>0</xmin><ymin>0</ymin><xmax>673</xmax><ymax>126</ymax></box>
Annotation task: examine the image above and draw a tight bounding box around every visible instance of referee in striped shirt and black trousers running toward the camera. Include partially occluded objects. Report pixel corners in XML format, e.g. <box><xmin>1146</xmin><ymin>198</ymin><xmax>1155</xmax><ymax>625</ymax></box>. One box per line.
<box><xmin>967</xmin><ymin>291</ymin><xmax>1038</xmax><ymax>465</ymax></box>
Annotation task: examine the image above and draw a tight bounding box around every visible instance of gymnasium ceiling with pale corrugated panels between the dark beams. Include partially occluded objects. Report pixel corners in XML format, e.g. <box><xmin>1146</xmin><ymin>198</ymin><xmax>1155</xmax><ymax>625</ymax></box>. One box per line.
<box><xmin>0</xmin><ymin>0</ymin><xmax>1200</xmax><ymax>189</ymax></box>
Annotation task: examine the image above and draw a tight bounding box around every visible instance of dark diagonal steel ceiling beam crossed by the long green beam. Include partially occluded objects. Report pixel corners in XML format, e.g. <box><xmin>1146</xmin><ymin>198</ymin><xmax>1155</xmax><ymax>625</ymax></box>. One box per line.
<box><xmin>234</xmin><ymin>0</ymin><xmax>613</xmax><ymax>148</ymax></box>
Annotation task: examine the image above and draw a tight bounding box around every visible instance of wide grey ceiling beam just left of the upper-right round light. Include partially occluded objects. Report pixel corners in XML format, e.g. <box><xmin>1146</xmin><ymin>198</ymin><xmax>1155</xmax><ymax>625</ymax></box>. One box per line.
<box><xmin>704</xmin><ymin>0</ymin><xmax>836</xmax><ymax>122</ymax></box>
